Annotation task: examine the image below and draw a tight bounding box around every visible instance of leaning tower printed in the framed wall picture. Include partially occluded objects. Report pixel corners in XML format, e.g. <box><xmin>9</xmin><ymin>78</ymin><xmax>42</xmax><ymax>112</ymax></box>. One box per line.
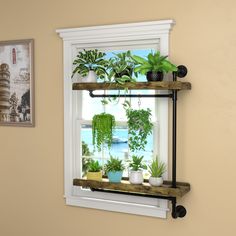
<box><xmin>0</xmin><ymin>63</ymin><xmax>10</xmax><ymax>122</ymax></box>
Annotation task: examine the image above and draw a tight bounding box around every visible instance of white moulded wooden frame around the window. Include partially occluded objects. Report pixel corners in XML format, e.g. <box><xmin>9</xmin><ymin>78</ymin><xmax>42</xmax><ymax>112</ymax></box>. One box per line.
<box><xmin>56</xmin><ymin>20</ymin><xmax>174</xmax><ymax>218</ymax></box>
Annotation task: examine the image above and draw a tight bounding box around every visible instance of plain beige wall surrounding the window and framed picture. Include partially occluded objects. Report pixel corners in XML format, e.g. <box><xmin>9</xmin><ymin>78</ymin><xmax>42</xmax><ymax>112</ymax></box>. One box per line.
<box><xmin>0</xmin><ymin>0</ymin><xmax>236</xmax><ymax>236</ymax></box>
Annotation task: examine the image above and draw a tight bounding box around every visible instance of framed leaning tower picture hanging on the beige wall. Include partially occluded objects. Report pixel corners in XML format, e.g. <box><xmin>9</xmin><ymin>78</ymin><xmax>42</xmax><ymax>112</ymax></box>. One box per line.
<box><xmin>0</xmin><ymin>39</ymin><xmax>34</xmax><ymax>127</ymax></box>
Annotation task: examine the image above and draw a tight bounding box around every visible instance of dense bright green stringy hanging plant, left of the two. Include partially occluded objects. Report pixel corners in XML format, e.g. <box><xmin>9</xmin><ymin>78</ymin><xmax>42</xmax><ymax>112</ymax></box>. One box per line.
<box><xmin>92</xmin><ymin>113</ymin><xmax>115</xmax><ymax>151</ymax></box>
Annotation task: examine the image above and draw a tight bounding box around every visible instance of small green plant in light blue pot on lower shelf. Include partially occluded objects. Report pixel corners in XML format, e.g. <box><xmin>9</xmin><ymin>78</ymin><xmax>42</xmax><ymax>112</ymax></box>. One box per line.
<box><xmin>104</xmin><ymin>156</ymin><xmax>125</xmax><ymax>183</ymax></box>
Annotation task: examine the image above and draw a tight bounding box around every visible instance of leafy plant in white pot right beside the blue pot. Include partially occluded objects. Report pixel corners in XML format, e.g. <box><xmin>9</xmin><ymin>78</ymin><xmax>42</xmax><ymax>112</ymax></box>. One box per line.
<box><xmin>129</xmin><ymin>155</ymin><xmax>147</xmax><ymax>184</ymax></box>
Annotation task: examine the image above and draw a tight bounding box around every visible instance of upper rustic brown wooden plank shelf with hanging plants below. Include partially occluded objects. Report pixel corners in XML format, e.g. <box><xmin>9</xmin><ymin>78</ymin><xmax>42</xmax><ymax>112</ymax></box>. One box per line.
<box><xmin>73</xmin><ymin>81</ymin><xmax>191</xmax><ymax>90</ymax></box>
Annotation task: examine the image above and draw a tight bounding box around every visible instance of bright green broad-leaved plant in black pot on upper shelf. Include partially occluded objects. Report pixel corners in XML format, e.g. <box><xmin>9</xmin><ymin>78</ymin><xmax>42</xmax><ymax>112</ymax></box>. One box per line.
<box><xmin>132</xmin><ymin>51</ymin><xmax>177</xmax><ymax>81</ymax></box>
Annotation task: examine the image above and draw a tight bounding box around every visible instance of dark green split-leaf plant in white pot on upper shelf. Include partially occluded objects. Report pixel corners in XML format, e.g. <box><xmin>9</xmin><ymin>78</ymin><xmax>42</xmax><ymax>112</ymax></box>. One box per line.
<box><xmin>72</xmin><ymin>49</ymin><xmax>108</xmax><ymax>82</ymax></box>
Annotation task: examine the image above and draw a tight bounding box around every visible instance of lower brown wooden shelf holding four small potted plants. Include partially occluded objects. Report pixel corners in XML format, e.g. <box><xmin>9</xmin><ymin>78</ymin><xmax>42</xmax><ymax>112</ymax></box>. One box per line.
<box><xmin>73</xmin><ymin>179</ymin><xmax>190</xmax><ymax>197</ymax></box>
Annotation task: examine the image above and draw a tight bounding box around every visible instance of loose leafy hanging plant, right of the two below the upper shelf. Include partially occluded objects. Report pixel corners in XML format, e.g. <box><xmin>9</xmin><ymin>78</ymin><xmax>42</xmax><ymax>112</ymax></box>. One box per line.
<box><xmin>126</xmin><ymin>108</ymin><xmax>153</xmax><ymax>151</ymax></box>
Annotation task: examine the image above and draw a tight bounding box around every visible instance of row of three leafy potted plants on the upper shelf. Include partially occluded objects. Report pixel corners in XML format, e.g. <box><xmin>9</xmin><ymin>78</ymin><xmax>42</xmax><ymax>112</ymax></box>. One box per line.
<box><xmin>72</xmin><ymin>49</ymin><xmax>177</xmax><ymax>82</ymax></box>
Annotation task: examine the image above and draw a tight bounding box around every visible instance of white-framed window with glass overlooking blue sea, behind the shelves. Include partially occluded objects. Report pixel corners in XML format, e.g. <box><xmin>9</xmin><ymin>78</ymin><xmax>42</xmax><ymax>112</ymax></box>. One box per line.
<box><xmin>57</xmin><ymin>20</ymin><xmax>173</xmax><ymax>218</ymax></box>
